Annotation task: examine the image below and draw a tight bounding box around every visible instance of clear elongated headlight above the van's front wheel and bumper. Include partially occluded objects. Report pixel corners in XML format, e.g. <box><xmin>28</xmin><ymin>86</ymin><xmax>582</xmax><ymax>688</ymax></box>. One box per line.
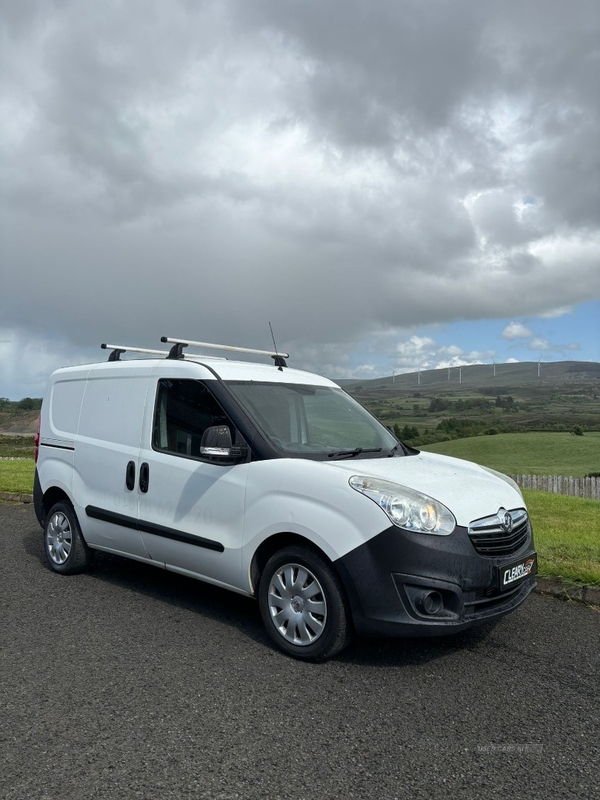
<box><xmin>348</xmin><ymin>475</ymin><xmax>456</xmax><ymax>536</ymax></box>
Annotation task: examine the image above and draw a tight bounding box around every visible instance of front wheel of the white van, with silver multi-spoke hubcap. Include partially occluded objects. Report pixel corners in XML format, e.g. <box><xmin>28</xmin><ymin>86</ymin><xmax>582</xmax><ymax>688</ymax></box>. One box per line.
<box><xmin>258</xmin><ymin>545</ymin><xmax>351</xmax><ymax>661</ymax></box>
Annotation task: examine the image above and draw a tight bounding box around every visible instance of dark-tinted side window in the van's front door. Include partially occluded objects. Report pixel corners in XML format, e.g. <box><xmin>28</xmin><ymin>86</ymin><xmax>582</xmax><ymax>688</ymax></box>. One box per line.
<box><xmin>152</xmin><ymin>379</ymin><xmax>235</xmax><ymax>458</ymax></box>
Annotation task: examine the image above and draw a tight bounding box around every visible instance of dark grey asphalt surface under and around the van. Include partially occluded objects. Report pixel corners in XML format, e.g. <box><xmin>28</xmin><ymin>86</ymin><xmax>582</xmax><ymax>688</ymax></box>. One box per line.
<box><xmin>0</xmin><ymin>505</ymin><xmax>600</xmax><ymax>800</ymax></box>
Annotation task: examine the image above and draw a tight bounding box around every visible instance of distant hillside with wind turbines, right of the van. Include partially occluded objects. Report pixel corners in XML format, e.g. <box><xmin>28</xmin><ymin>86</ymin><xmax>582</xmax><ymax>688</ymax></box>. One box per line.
<box><xmin>343</xmin><ymin>361</ymin><xmax>600</xmax><ymax>443</ymax></box>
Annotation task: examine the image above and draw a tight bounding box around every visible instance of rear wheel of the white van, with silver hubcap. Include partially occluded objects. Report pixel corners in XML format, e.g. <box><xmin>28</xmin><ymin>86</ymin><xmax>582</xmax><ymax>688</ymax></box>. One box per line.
<box><xmin>44</xmin><ymin>502</ymin><xmax>92</xmax><ymax>575</ymax></box>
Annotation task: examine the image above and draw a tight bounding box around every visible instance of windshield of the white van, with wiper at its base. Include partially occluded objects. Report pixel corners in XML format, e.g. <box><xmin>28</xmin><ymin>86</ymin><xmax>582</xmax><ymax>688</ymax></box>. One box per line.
<box><xmin>227</xmin><ymin>381</ymin><xmax>403</xmax><ymax>458</ymax></box>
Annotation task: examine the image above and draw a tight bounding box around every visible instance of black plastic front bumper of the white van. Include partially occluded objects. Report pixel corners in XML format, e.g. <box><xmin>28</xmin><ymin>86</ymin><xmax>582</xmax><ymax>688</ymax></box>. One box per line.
<box><xmin>336</xmin><ymin>523</ymin><xmax>535</xmax><ymax>636</ymax></box>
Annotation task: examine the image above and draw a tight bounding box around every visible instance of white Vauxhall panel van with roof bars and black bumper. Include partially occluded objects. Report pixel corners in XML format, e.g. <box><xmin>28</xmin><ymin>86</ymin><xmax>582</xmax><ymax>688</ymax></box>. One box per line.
<box><xmin>34</xmin><ymin>337</ymin><xmax>536</xmax><ymax>660</ymax></box>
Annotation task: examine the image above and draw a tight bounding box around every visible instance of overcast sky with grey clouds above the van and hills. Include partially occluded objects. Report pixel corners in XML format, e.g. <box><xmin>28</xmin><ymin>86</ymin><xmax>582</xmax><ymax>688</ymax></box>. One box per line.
<box><xmin>0</xmin><ymin>0</ymin><xmax>600</xmax><ymax>399</ymax></box>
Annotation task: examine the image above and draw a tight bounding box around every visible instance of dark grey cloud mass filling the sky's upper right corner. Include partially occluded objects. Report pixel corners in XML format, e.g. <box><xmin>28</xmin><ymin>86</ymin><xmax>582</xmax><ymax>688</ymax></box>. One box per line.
<box><xmin>240</xmin><ymin>0</ymin><xmax>600</xmax><ymax>216</ymax></box>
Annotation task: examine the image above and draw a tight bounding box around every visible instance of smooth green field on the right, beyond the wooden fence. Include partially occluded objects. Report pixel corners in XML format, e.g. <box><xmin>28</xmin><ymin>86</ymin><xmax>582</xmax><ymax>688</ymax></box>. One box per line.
<box><xmin>419</xmin><ymin>431</ymin><xmax>600</xmax><ymax>477</ymax></box>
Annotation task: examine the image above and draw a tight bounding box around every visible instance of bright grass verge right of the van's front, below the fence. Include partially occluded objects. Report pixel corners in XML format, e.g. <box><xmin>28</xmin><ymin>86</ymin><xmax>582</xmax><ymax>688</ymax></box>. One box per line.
<box><xmin>523</xmin><ymin>489</ymin><xmax>600</xmax><ymax>586</ymax></box>
